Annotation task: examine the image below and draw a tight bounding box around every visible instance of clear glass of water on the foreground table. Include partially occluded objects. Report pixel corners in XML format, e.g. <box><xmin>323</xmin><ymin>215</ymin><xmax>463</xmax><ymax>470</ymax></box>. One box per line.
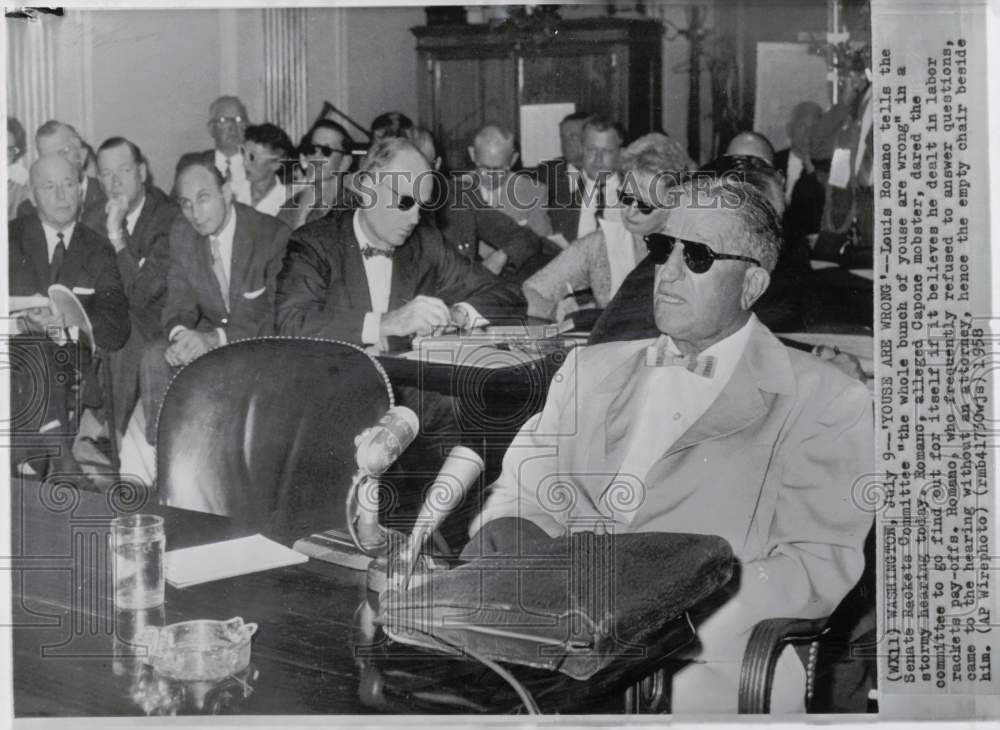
<box><xmin>111</xmin><ymin>514</ymin><xmax>166</xmax><ymax>609</ymax></box>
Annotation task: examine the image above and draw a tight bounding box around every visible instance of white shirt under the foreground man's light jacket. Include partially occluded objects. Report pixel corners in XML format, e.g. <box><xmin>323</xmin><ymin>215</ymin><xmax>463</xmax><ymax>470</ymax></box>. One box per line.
<box><xmin>606</xmin><ymin>314</ymin><xmax>756</xmax><ymax>522</ymax></box>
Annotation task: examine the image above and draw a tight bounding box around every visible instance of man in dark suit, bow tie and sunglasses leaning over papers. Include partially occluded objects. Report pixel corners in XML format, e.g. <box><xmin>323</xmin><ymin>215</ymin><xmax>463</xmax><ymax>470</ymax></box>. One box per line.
<box><xmin>277</xmin><ymin>138</ymin><xmax>524</xmax><ymax>349</ymax></box>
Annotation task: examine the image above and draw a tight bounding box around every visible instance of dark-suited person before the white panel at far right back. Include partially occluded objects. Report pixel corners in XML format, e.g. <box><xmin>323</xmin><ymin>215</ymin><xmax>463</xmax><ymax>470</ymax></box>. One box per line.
<box><xmin>774</xmin><ymin>101</ymin><xmax>826</xmax><ymax>241</ymax></box>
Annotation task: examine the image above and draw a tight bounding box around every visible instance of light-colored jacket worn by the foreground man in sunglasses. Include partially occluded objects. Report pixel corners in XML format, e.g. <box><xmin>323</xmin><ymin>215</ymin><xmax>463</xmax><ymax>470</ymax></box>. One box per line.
<box><xmin>471</xmin><ymin>321</ymin><xmax>874</xmax><ymax>707</ymax></box>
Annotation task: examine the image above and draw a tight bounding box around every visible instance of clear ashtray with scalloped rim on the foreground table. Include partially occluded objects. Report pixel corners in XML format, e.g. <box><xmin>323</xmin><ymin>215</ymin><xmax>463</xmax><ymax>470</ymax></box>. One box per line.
<box><xmin>137</xmin><ymin>616</ymin><xmax>257</xmax><ymax>682</ymax></box>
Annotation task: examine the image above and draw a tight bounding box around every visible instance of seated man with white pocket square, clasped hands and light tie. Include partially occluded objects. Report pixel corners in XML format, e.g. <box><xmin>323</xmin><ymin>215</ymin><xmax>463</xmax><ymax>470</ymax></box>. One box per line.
<box><xmin>141</xmin><ymin>153</ymin><xmax>290</xmax><ymax>444</ymax></box>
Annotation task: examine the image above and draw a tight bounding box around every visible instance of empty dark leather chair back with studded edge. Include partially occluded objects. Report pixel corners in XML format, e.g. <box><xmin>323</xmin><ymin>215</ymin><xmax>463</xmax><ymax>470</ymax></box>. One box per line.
<box><xmin>156</xmin><ymin>337</ymin><xmax>393</xmax><ymax>542</ymax></box>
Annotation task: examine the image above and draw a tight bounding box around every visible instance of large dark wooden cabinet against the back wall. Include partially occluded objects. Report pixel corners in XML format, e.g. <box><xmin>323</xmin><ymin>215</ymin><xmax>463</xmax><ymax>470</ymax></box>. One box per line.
<box><xmin>413</xmin><ymin>17</ymin><xmax>663</xmax><ymax>170</ymax></box>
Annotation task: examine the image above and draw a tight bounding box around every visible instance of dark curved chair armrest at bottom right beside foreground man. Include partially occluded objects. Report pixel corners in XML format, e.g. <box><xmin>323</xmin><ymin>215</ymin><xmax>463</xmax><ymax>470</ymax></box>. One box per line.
<box><xmin>738</xmin><ymin>618</ymin><xmax>829</xmax><ymax>714</ymax></box>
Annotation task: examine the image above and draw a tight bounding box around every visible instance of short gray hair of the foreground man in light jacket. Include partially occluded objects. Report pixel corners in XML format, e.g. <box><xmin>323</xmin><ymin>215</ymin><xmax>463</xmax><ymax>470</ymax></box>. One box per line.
<box><xmin>680</xmin><ymin>174</ymin><xmax>783</xmax><ymax>273</ymax></box>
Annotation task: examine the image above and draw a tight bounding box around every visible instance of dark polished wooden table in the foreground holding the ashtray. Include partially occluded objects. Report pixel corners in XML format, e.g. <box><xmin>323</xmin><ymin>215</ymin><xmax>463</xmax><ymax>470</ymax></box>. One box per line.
<box><xmin>10</xmin><ymin>480</ymin><xmax>724</xmax><ymax>718</ymax></box>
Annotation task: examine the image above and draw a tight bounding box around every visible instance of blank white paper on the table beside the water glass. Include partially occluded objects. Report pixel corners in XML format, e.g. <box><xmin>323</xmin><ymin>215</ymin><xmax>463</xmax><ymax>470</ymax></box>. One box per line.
<box><xmin>163</xmin><ymin>534</ymin><xmax>309</xmax><ymax>588</ymax></box>
